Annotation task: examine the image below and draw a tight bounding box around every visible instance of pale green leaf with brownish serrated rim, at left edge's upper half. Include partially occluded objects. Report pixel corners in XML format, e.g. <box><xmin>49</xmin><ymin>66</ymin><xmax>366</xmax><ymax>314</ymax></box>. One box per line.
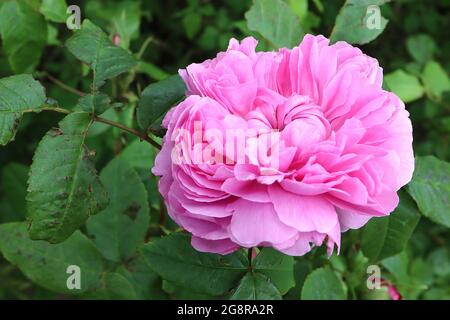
<box><xmin>0</xmin><ymin>74</ymin><xmax>46</xmax><ymax>145</ymax></box>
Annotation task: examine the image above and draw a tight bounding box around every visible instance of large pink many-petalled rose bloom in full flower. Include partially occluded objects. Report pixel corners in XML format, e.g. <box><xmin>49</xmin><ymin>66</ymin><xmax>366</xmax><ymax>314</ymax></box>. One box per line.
<box><xmin>153</xmin><ymin>35</ymin><xmax>414</xmax><ymax>256</ymax></box>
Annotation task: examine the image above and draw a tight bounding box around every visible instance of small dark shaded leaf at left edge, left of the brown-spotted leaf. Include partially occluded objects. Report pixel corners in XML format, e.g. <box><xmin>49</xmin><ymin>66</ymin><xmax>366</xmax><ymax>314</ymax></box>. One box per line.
<box><xmin>0</xmin><ymin>162</ymin><xmax>29</xmax><ymax>220</ymax></box>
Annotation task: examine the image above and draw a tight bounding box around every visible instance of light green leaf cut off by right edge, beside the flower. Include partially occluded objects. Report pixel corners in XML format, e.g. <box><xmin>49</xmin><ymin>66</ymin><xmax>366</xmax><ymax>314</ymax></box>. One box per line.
<box><xmin>407</xmin><ymin>156</ymin><xmax>450</xmax><ymax>227</ymax></box>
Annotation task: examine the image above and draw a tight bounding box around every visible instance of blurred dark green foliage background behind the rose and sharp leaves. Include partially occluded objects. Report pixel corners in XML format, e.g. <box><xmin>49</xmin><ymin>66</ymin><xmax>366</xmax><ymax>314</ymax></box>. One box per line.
<box><xmin>0</xmin><ymin>0</ymin><xmax>450</xmax><ymax>299</ymax></box>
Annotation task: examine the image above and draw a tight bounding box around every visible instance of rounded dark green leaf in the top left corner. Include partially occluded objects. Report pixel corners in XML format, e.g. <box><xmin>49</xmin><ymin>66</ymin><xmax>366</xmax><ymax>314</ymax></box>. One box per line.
<box><xmin>0</xmin><ymin>0</ymin><xmax>47</xmax><ymax>73</ymax></box>
